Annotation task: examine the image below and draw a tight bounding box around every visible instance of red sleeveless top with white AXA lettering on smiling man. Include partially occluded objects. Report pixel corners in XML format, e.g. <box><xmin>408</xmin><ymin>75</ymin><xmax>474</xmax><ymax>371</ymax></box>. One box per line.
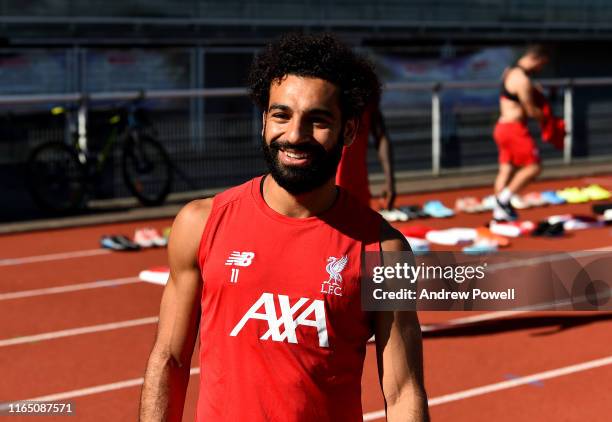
<box><xmin>196</xmin><ymin>177</ymin><xmax>381</xmax><ymax>422</ymax></box>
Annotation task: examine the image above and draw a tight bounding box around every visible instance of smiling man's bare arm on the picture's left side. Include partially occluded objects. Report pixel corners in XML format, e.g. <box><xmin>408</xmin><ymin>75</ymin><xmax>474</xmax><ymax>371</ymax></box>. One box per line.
<box><xmin>140</xmin><ymin>199</ymin><xmax>212</xmax><ymax>422</ymax></box>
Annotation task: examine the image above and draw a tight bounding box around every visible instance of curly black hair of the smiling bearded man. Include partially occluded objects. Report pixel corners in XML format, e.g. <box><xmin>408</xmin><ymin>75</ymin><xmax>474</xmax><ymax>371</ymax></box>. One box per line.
<box><xmin>248</xmin><ymin>33</ymin><xmax>380</xmax><ymax>120</ymax></box>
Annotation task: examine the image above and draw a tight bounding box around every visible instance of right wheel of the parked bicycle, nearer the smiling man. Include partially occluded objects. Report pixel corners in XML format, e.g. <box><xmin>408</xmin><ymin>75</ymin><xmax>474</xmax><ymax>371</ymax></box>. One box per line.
<box><xmin>122</xmin><ymin>135</ymin><xmax>172</xmax><ymax>206</ymax></box>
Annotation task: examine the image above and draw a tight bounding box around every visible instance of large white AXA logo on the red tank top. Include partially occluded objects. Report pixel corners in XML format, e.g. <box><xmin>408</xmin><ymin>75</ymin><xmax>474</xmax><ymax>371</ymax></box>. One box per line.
<box><xmin>230</xmin><ymin>293</ymin><xmax>329</xmax><ymax>347</ymax></box>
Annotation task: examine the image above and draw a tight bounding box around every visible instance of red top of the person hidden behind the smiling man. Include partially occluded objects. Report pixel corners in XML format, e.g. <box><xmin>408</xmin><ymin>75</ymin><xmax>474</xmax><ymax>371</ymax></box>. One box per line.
<box><xmin>336</xmin><ymin>107</ymin><xmax>372</xmax><ymax>207</ymax></box>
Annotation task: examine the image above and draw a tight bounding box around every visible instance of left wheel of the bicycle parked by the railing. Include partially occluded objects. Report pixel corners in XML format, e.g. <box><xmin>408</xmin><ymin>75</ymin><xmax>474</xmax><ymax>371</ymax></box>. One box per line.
<box><xmin>26</xmin><ymin>142</ymin><xmax>85</xmax><ymax>213</ymax></box>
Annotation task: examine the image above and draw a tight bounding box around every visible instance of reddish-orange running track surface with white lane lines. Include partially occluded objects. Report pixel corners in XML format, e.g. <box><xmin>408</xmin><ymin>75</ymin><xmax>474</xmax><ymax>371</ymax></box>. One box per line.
<box><xmin>0</xmin><ymin>177</ymin><xmax>612</xmax><ymax>422</ymax></box>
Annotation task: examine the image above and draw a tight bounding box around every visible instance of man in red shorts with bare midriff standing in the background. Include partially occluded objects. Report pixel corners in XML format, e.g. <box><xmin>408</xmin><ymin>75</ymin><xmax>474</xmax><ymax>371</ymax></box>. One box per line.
<box><xmin>493</xmin><ymin>45</ymin><xmax>548</xmax><ymax>221</ymax></box>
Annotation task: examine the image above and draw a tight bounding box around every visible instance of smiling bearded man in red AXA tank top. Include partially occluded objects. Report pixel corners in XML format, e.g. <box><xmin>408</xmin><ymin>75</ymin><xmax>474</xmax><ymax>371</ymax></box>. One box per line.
<box><xmin>140</xmin><ymin>35</ymin><xmax>428</xmax><ymax>422</ymax></box>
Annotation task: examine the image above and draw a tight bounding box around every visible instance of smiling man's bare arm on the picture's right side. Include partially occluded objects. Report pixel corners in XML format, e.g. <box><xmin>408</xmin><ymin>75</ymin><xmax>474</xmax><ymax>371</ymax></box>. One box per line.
<box><xmin>375</xmin><ymin>223</ymin><xmax>429</xmax><ymax>422</ymax></box>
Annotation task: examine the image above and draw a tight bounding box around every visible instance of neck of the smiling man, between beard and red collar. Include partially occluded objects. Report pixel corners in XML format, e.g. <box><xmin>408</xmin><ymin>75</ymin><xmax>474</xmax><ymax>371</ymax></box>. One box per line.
<box><xmin>262</xmin><ymin>175</ymin><xmax>338</xmax><ymax>218</ymax></box>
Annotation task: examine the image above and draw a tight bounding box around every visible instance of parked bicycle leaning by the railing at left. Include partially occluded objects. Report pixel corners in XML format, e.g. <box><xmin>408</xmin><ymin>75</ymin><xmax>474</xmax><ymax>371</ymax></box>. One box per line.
<box><xmin>26</xmin><ymin>99</ymin><xmax>173</xmax><ymax>213</ymax></box>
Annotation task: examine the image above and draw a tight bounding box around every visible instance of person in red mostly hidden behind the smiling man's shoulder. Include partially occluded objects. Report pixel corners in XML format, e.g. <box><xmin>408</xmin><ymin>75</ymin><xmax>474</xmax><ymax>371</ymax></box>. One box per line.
<box><xmin>336</xmin><ymin>89</ymin><xmax>396</xmax><ymax>210</ymax></box>
